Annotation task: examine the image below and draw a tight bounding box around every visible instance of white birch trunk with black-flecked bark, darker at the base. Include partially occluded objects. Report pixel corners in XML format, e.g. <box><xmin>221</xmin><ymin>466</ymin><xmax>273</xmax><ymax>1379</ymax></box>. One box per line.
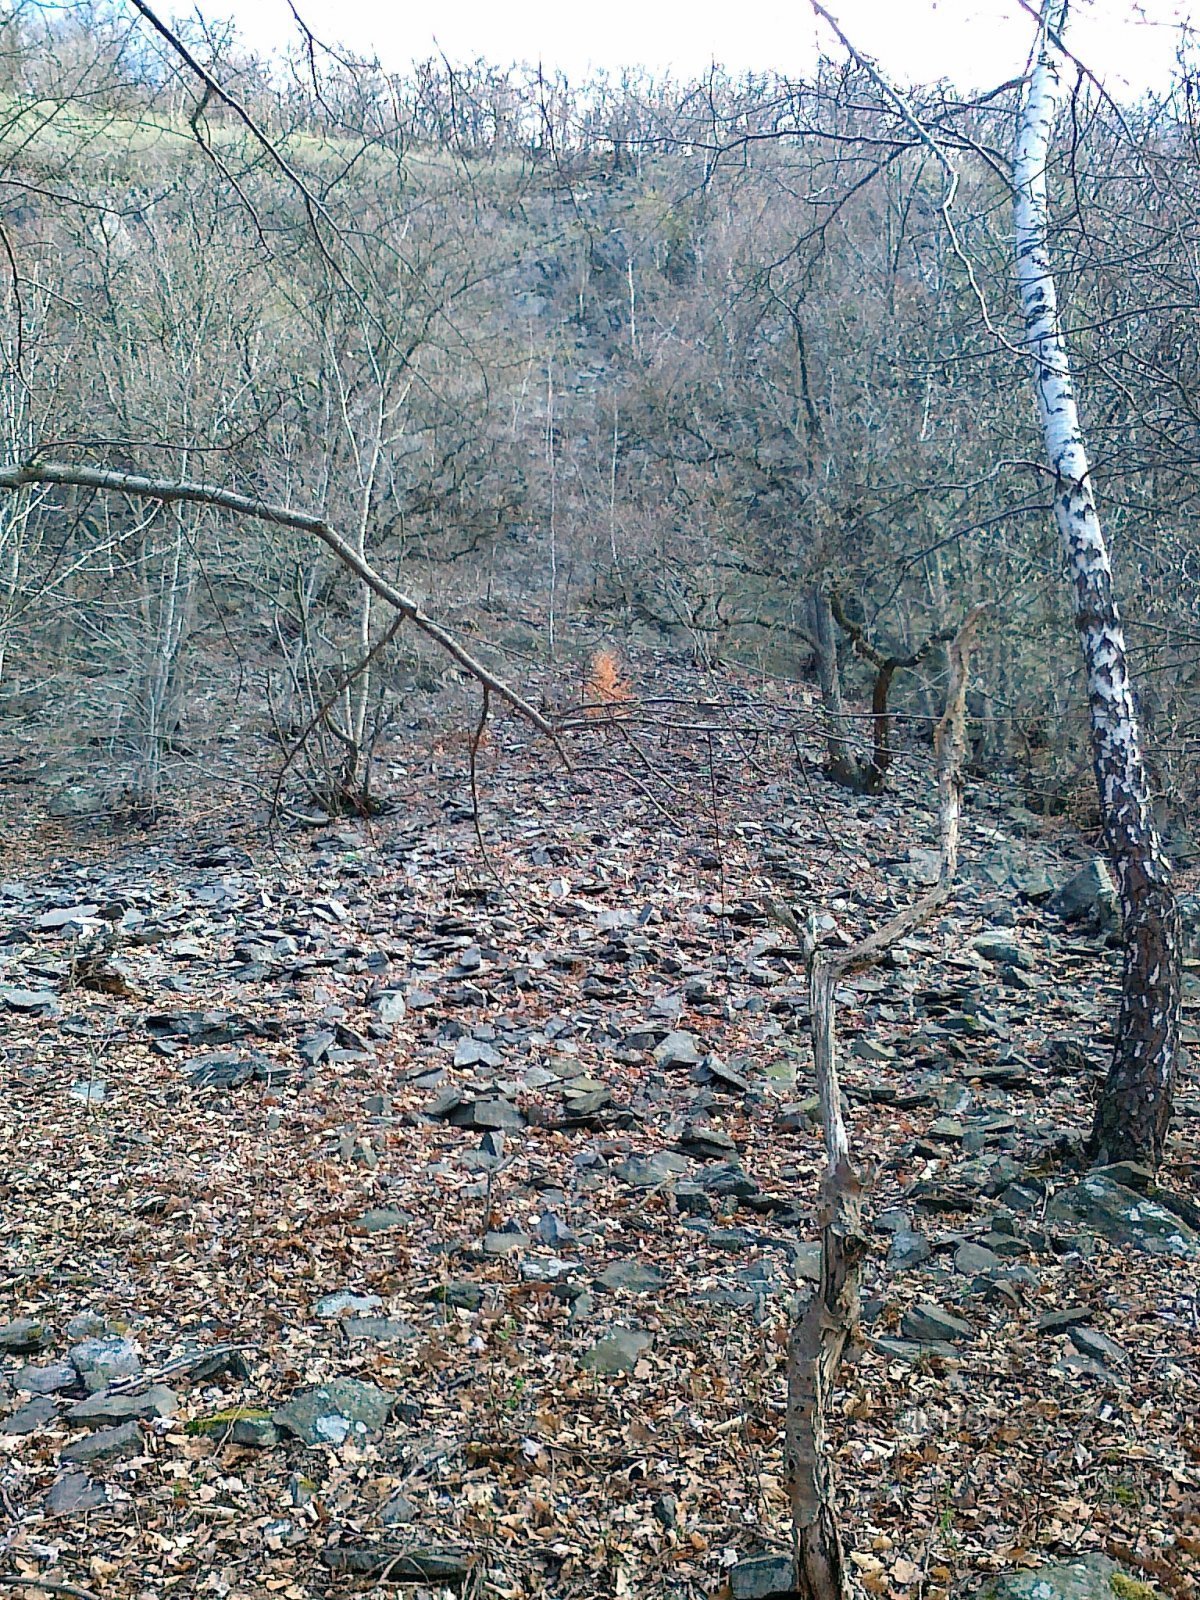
<box><xmin>1013</xmin><ymin>0</ymin><xmax>1179</xmax><ymax>1166</ymax></box>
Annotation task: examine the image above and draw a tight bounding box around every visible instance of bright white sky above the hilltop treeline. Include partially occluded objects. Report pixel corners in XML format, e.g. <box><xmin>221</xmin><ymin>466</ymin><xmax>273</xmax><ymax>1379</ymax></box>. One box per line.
<box><xmin>211</xmin><ymin>0</ymin><xmax>1200</xmax><ymax>94</ymax></box>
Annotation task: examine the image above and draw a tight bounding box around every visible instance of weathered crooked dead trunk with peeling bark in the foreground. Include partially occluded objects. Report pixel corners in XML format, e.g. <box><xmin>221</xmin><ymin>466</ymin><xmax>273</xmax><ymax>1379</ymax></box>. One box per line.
<box><xmin>790</xmin><ymin>606</ymin><xmax>984</xmax><ymax>1600</ymax></box>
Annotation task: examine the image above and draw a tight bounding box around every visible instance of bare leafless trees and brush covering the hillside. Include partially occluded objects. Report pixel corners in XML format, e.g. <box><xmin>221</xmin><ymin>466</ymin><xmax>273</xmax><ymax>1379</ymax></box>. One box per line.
<box><xmin>0</xmin><ymin>5</ymin><xmax>1200</xmax><ymax>821</ymax></box>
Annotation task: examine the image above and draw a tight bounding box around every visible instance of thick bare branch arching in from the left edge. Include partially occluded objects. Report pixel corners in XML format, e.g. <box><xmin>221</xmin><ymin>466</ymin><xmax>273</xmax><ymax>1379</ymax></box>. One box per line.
<box><xmin>0</xmin><ymin>458</ymin><xmax>570</xmax><ymax>766</ymax></box>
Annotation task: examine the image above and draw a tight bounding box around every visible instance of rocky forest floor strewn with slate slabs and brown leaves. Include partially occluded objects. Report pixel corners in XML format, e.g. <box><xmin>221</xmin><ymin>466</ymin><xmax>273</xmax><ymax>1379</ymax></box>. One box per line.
<box><xmin>0</xmin><ymin>656</ymin><xmax>1200</xmax><ymax>1600</ymax></box>
